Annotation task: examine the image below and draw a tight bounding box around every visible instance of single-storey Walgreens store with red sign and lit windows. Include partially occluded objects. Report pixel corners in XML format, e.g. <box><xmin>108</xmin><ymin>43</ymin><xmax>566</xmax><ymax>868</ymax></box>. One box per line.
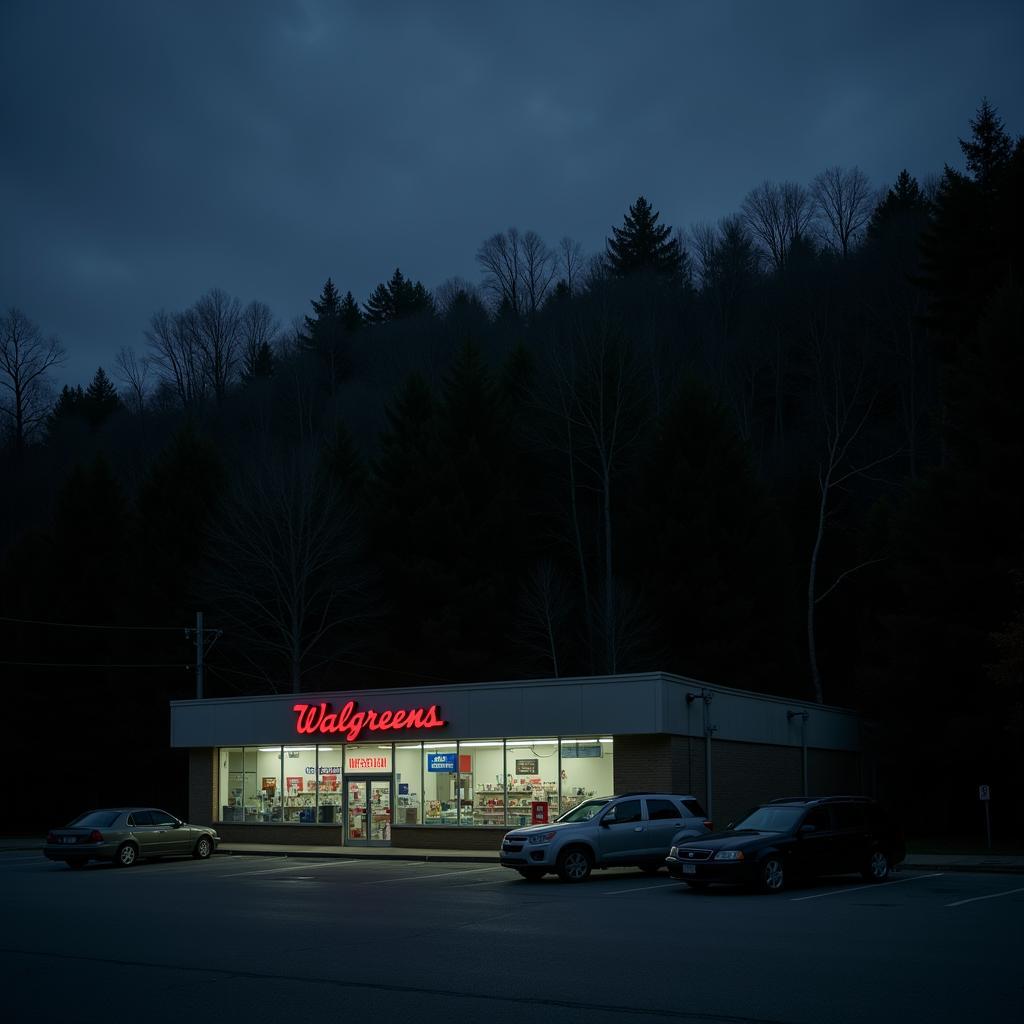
<box><xmin>171</xmin><ymin>673</ymin><xmax>873</xmax><ymax>849</ymax></box>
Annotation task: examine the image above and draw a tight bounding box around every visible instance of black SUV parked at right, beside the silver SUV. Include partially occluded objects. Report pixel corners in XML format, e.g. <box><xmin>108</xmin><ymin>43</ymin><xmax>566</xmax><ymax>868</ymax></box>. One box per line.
<box><xmin>666</xmin><ymin>797</ymin><xmax>905</xmax><ymax>893</ymax></box>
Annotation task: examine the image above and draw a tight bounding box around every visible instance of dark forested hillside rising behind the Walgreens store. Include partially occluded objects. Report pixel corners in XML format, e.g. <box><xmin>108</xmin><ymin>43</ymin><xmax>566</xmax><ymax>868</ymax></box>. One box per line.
<box><xmin>0</xmin><ymin>102</ymin><xmax>1024</xmax><ymax>830</ymax></box>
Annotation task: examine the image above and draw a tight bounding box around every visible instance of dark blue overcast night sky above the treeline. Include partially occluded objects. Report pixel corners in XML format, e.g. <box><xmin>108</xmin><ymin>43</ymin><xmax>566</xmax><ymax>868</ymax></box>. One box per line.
<box><xmin>0</xmin><ymin>0</ymin><xmax>1024</xmax><ymax>383</ymax></box>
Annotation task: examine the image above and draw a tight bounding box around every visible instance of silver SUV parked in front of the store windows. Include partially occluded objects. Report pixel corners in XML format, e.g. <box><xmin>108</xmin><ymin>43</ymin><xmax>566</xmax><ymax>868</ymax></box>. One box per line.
<box><xmin>501</xmin><ymin>793</ymin><xmax>711</xmax><ymax>882</ymax></box>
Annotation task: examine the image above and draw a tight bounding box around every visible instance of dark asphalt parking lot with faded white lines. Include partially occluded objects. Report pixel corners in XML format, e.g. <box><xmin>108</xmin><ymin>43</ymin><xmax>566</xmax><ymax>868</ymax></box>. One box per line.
<box><xmin>0</xmin><ymin>851</ymin><xmax>1024</xmax><ymax>1024</ymax></box>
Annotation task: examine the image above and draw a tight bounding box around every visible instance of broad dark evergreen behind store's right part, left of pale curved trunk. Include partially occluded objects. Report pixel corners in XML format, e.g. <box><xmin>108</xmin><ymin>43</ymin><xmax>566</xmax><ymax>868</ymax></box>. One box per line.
<box><xmin>625</xmin><ymin>372</ymin><xmax>794</xmax><ymax>689</ymax></box>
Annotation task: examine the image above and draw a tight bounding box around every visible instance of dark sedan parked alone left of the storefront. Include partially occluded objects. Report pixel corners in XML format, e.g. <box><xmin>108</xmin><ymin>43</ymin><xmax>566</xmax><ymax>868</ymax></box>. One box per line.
<box><xmin>43</xmin><ymin>807</ymin><xmax>220</xmax><ymax>867</ymax></box>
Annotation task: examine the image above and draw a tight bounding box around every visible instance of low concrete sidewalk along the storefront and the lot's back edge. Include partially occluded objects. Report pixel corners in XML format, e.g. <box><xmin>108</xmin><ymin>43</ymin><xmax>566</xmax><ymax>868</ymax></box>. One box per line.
<box><xmin>0</xmin><ymin>836</ymin><xmax>1024</xmax><ymax>874</ymax></box>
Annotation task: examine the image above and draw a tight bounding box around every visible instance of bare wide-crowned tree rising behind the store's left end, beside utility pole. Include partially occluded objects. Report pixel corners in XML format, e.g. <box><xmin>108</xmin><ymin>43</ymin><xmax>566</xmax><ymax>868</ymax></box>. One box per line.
<box><xmin>208</xmin><ymin>439</ymin><xmax>366</xmax><ymax>692</ymax></box>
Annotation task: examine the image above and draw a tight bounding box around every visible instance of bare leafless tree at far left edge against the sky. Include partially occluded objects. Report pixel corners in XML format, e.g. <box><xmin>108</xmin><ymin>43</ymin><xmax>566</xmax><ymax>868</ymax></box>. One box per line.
<box><xmin>0</xmin><ymin>307</ymin><xmax>66</xmax><ymax>458</ymax></box>
